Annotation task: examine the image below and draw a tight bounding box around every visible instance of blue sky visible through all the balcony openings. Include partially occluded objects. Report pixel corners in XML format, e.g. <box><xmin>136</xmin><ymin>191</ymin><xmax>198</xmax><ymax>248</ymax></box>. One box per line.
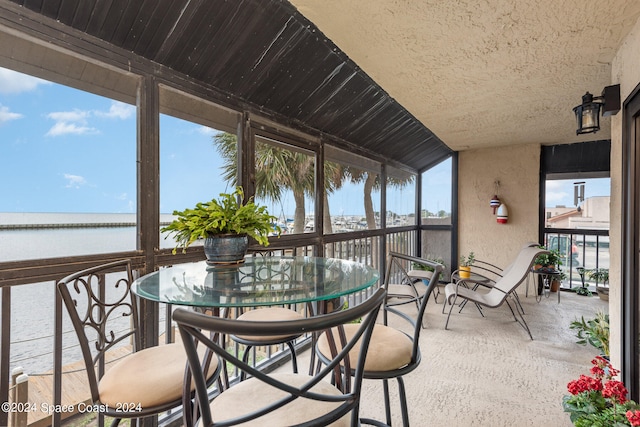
<box><xmin>0</xmin><ymin>68</ymin><xmax>608</xmax><ymax>216</ymax></box>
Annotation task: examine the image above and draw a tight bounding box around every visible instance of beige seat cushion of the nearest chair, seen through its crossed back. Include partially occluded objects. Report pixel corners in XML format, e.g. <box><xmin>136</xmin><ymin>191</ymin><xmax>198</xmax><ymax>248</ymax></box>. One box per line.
<box><xmin>210</xmin><ymin>374</ymin><xmax>351</xmax><ymax>427</ymax></box>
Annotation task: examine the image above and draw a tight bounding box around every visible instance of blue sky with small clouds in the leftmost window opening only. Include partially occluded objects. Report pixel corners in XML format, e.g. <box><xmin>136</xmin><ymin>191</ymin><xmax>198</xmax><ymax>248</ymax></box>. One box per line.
<box><xmin>0</xmin><ymin>69</ymin><xmax>135</xmax><ymax>212</ymax></box>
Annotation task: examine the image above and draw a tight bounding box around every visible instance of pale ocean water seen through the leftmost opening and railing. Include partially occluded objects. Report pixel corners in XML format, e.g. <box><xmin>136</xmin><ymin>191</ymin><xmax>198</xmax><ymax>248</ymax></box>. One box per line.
<box><xmin>0</xmin><ymin>213</ymin><xmax>179</xmax><ymax>375</ymax></box>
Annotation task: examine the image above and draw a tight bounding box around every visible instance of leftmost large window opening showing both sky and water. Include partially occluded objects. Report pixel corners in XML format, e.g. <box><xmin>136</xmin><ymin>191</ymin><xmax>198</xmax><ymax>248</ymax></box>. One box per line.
<box><xmin>0</xmin><ymin>69</ymin><xmax>136</xmax><ymax>261</ymax></box>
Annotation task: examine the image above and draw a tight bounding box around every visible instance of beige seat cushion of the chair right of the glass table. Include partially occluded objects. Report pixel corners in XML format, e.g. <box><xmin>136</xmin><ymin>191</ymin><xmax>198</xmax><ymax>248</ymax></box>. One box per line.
<box><xmin>318</xmin><ymin>323</ymin><xmax>413</xmax><ymax>372</ymax></box>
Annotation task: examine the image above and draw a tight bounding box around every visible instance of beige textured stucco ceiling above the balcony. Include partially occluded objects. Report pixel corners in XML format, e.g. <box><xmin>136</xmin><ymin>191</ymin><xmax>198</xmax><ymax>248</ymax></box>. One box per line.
<box><xmin>291</xmin><ymin>0</ymin><xmax>640</xmax><ymax>150</ymax></box>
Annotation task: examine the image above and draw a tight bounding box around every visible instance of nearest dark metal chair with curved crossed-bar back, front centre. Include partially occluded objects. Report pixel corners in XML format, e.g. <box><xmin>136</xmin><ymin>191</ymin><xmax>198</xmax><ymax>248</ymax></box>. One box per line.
<box><xmin>173</xmin><ymin>289</ymin><xmax>385</xmax><ymax>427</ymax></box>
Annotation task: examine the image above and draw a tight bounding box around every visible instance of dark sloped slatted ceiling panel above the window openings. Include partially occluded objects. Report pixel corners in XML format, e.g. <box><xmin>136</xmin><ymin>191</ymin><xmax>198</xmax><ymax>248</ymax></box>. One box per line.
<box><xmin>12</xmin><ymin>0</ymin><xmax>451</xmax><ymax>170</ymax></box>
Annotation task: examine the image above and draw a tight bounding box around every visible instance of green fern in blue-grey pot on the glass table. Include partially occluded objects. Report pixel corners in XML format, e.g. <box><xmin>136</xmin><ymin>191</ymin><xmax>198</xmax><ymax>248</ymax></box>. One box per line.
<box><xmin>161</xmin><ymin>187</ymin><xmax>281</xmax><ymax>265</ymax></box>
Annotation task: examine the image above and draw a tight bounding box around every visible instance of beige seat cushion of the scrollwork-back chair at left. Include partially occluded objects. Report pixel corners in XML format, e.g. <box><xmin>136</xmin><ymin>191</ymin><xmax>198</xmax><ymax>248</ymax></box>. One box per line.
<box><xmin>98</xmin><ymin>343</ymin><xmax>218</xmax><ymax>409</ymax></box>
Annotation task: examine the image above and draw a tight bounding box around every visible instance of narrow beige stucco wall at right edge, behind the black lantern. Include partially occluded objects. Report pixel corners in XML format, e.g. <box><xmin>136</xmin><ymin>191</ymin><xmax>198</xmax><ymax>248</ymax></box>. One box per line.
<box><xmin>609</xmin><ymin>15</ymin><xmax>640</xmax><ymax>366</ymax></box>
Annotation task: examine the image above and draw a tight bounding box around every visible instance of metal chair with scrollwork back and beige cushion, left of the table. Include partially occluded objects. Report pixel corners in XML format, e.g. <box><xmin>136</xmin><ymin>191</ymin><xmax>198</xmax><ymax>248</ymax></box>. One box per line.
<box><xmin>58</xmin><ymin>260</ymin><xmax>220</xmax><ymax>426</ymax></box>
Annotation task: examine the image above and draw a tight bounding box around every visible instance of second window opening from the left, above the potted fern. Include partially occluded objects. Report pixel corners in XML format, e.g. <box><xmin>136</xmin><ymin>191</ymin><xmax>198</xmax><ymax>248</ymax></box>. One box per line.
<box><xmin>160</xmin><ymin>86</ymin><xmax>239</xmax><ymax>248</ymax></box>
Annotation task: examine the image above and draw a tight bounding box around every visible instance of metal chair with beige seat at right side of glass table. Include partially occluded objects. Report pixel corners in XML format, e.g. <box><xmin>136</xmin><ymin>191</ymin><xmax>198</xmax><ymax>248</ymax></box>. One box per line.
<box><xmin>316</xmin><ymin>252</ymin><xmax>444</xmax><ymax>426</ymax></box>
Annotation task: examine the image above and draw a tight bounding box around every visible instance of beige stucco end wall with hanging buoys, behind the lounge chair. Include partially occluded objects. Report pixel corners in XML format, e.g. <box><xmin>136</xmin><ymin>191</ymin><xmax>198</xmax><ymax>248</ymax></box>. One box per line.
<box><xmin>458</xmin><ymin>144</ymin><xmax>540</xmax><ymax>267</ymax></box>
